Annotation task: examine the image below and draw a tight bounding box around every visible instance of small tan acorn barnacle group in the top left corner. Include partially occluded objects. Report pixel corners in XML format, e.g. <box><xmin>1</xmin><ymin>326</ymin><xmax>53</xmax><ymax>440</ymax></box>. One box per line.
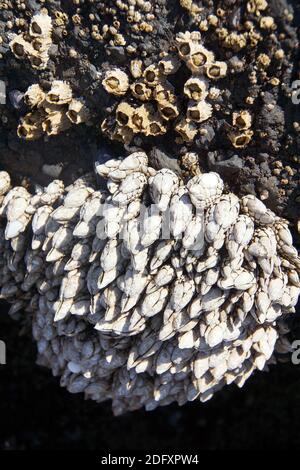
<box><xmin>9</xmin><ymin>13</ymin><xmax>52</xmax><ymax>70</ymax></box>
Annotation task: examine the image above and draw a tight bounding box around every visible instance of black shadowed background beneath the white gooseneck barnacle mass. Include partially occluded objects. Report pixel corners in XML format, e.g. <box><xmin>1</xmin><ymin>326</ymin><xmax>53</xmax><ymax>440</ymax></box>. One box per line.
<box><xmin>0</xmin><ymin>304</ymin><xmax>300</xmax><ymax>451</ymax></box>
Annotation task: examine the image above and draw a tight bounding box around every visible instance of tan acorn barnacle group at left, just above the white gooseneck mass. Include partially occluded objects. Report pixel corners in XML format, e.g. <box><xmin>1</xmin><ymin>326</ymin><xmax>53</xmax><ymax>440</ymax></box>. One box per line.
<box><xmin>17</xmin><ymin>80</ymin><xmax>90</xmax><ymax>140</ymax></box>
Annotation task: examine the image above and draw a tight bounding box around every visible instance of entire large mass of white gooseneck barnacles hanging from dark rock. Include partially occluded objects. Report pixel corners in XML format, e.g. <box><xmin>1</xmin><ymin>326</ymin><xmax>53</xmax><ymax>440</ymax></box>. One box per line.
<box><xmin>0</xmin><ymin>152</ymin><xmax>300</xmax><ymax>414</ymax></box>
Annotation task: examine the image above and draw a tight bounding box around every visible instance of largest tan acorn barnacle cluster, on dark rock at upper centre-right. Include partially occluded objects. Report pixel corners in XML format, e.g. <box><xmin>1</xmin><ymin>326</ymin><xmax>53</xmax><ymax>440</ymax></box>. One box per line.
<box><xmin>101</xmin><ymin>32</ymin><xmax>227</xmax><ymax>143</ymax></box>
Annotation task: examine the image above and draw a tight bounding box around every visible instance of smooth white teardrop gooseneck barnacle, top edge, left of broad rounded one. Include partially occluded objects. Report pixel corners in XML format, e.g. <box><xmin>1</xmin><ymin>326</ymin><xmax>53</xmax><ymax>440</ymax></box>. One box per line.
<box><xmin>149</xmin><ymin>169</ymin><xmax>179</xmax><ymax>211</ymax></box>
